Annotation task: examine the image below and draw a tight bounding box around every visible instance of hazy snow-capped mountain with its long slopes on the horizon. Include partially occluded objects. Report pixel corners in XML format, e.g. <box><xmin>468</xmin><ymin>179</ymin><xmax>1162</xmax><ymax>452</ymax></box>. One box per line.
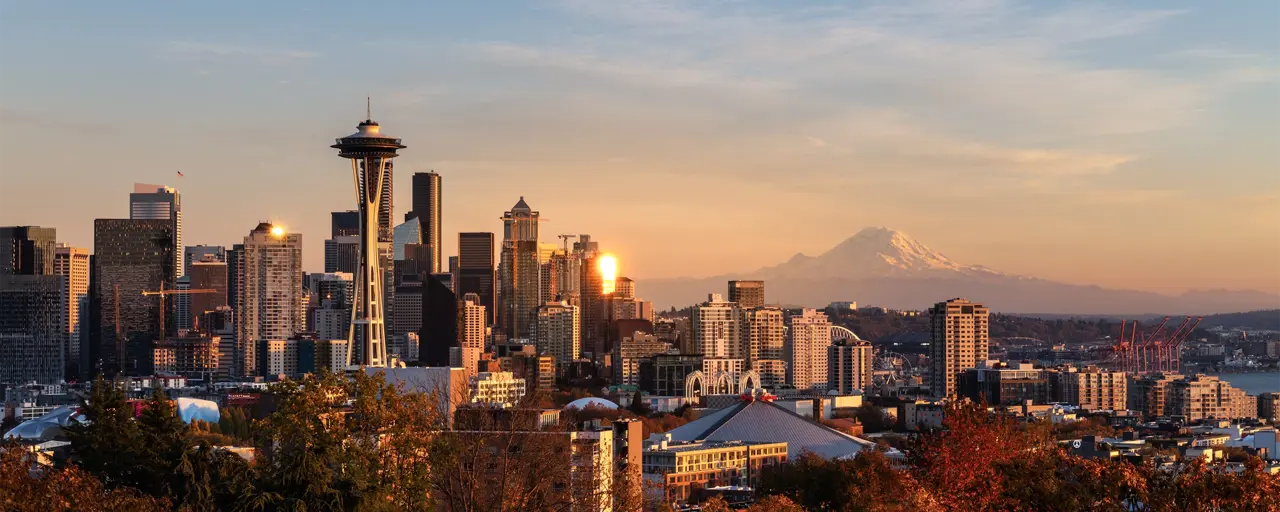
<box><xmin>636</xmin><ymin>228</ymin><xmax>1280</xmax><ymax>316</ymax></box>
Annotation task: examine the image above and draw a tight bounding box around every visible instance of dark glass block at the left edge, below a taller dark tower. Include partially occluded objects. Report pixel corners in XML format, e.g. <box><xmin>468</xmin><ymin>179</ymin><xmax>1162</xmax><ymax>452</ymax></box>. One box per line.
<box><xmin>0</xmin><ymin>275</ymin><xmax>67</xmax><ymax>384</ymax></box>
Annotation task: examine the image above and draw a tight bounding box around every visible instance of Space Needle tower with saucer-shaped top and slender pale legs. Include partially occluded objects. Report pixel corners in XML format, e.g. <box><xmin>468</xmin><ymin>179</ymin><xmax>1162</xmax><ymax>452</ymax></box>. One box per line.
<box><xmin>329</xmin><ymin>103</ymin><xmax>404</xmax><ymax>367</ymax></box>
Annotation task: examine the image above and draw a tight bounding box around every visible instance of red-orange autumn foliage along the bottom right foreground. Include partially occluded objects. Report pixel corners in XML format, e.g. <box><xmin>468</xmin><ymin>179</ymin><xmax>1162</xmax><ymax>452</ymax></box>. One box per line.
<box><xmin>760</xmin><ymin>404</ymin><xmax>1280</xmax><ymax>512</ymax></box>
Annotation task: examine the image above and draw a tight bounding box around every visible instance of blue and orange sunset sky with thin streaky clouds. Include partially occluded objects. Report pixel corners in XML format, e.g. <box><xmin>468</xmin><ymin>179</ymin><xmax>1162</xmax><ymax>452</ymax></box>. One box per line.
<box><xmin>0</xmin><ymin>0</ymin><xmax>1280</xmax><ymax>296</ymax></box>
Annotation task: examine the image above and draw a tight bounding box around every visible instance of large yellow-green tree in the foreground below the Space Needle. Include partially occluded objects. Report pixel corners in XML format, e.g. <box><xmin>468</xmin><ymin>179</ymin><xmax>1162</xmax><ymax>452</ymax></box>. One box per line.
<box><xmin>246</xmin><ymin>371</ymin><xmax>443</xmax><ymax>511</ymax></box>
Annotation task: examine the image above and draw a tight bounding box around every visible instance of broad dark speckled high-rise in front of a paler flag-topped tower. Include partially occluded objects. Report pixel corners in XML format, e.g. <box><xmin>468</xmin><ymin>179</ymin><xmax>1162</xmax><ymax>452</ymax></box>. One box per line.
<box><xmin>88</xmin><ymin>219</ymin><xmax>178</xmax><ymax>375</ymax></box>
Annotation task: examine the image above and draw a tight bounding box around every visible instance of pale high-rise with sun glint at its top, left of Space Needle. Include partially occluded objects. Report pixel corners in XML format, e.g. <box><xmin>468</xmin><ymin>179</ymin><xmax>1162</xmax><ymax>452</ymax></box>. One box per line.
<box><xmin>236</xmin><ymin>223</ymin><xmax>303</xmax><ymax>375</ymax></box>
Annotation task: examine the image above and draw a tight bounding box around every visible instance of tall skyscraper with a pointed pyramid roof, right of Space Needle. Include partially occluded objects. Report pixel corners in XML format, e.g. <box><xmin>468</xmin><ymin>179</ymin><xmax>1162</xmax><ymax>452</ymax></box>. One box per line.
<box><xmin>498</xmin><ymin>197</ymin><xmax>541</xmax><ymax>339</ymax></box>
